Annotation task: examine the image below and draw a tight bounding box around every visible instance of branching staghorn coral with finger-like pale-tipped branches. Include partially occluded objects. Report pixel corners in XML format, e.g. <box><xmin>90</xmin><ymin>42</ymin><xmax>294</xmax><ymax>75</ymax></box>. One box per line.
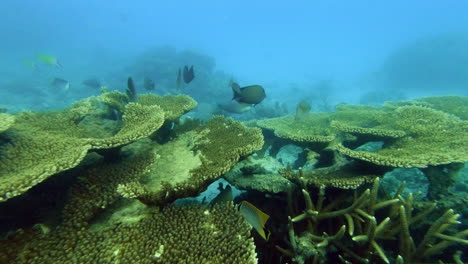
<box><xmin>277</xmin><ymin>178</ymin><xmax>468</xmax><ymax>263</ymax></box>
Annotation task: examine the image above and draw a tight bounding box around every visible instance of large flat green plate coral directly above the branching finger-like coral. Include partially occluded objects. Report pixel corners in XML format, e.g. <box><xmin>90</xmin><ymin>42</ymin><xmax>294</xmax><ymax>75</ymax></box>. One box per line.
<box><xmin>337</xmin><ymin>106</ymin><xmax>468</xmax><ymax>168</ymax></box>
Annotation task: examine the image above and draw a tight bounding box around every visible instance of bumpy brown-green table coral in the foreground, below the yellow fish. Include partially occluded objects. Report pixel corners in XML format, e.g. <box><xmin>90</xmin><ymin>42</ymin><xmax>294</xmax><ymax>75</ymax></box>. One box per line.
<box><xmin>0</xmin><ymin>203</ymin><xmax>257</xmax><ymax>264</ymax></box>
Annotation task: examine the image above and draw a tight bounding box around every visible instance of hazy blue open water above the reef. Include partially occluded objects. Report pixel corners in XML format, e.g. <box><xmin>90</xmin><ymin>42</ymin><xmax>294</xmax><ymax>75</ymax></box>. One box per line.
<box><xmin>0</xmin><ymin>0</ymin><xmax>468</xmax><ymax>111</ymax></box>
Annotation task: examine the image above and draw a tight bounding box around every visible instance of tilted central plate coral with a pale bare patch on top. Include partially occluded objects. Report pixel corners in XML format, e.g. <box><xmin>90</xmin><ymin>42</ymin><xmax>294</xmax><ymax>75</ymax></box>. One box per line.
<box><xmin>119</xmin><ymin>116</ymin><xmax>263</xmax><ymax>205</ymax></box>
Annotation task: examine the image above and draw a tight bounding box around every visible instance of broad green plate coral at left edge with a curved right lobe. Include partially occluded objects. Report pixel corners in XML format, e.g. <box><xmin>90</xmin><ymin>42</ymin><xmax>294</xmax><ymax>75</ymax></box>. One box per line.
<box><xmin>0</xmin><ymin>103</ymin><xmax>164</xmax><ymax>201</ymax></box>
